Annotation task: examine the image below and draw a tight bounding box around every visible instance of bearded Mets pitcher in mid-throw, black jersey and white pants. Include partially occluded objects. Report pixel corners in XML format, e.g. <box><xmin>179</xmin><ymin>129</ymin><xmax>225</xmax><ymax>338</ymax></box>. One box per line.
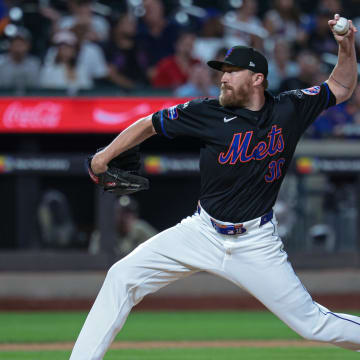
<box><xmin>70</xmin><ymin>15</ymin><xmax>360</xmax><ymax>360</ymax></box>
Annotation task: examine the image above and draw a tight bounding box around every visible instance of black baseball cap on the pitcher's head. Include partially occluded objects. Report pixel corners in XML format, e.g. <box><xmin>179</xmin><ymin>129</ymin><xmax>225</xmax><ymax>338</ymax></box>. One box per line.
<box><xmin>207</xmin><ymin>46</ymin><xmax>268</xmax><ymax>78</ymax></box>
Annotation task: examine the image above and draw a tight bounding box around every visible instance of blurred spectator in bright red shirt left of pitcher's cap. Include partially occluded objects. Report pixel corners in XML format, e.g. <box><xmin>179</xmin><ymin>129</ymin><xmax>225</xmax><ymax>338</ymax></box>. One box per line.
<box><xmin>152</xmin><ymin>32</ymin><xmax>200</xmax><ymax>89</ymax></box>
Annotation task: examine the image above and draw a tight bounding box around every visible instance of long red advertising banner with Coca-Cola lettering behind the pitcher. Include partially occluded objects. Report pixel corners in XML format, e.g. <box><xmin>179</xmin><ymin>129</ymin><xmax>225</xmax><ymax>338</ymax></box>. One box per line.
<box><xmin>0</xmin><ymin>97</ymin><xmax>188</xmax><ymax>133</ymax></box>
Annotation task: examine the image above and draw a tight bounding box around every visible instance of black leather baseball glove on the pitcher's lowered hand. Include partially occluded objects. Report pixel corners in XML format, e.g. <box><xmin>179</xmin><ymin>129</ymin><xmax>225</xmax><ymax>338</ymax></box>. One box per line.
<box><xmin>87</xmin><ymin>146</ymin><xmax>149</xmax><ymax>196</ymax></box>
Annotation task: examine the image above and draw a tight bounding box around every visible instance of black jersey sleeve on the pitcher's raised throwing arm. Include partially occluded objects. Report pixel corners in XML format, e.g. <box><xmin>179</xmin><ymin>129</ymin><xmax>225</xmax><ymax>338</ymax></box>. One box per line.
<box><xmin>284</xmin><ymin>82</ymin><xmax>336</xmax><ymax>132</ymax></box>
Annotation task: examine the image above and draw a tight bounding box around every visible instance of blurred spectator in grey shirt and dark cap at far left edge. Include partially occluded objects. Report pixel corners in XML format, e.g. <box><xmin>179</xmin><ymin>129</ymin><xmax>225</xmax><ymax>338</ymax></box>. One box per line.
<box><xmin>0</xmin><ymin>28</ymin><xmax>40</xmax><ymax>90</ymax></box>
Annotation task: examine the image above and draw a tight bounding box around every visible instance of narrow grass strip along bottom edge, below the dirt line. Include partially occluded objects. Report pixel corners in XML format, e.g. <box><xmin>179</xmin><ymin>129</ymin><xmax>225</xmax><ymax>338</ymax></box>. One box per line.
<box><xmin>0</xmin><ymin>348</ymin><xmax>359</xmax><ymax>360</ymax></box>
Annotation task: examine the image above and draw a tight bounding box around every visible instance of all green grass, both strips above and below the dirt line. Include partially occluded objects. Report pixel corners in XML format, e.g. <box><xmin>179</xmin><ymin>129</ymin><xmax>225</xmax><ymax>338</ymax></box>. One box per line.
<box><xmin>0</xmin><ymin>311</ymin><xmax>359</xmax><ymax>360</ymax></box>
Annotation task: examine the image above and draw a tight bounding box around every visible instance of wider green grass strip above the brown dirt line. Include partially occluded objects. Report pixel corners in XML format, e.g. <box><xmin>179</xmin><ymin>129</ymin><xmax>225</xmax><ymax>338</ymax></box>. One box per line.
<box><xmin>0</xmin><ymin>311</ymin><xmax>299</xmax><ymax>343</ymax></box>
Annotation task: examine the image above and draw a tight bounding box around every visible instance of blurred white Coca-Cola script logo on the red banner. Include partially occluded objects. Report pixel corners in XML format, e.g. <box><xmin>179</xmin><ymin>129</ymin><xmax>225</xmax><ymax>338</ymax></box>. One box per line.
<box><xmin>2</xmin><ymin>101</ymin><xmax>62</xmax><ymax>129</ymax></box>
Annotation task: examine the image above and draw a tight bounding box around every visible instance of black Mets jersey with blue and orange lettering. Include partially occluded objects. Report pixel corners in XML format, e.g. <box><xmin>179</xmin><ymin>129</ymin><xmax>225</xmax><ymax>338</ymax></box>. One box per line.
<box><xmin>152</xmin><ymin>83</ymin><xmax>336</xmax><ymax>223</ymax></box>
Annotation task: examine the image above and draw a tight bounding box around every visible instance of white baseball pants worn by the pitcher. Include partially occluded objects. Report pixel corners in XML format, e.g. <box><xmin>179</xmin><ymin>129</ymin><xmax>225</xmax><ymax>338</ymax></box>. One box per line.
<box><xmin>70</xmin><ymin>204</ymin><xmax>360</xmax><ymax>360</ymax></box>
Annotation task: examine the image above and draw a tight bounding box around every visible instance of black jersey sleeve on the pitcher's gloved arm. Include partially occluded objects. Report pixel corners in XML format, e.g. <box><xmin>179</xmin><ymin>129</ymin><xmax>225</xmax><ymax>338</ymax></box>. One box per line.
<box><xmin>152</xmin><ymin>99</ymin><xmax>206</xmax><ymax>139</ymax></box>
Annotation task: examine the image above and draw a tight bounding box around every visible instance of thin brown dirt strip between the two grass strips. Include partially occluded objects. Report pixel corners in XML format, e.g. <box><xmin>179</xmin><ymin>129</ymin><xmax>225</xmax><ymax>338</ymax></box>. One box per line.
<box><xmin>0</xmin><ymin>340</ymin><xmax>331</xmax><ymax>351</ymax></box>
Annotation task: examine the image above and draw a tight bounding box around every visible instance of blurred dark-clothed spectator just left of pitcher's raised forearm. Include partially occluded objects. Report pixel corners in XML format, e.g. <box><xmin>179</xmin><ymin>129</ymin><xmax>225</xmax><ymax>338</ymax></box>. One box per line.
<box><xmin>279</xmin><ymin>50</ymin><xmax>325</xmax><ymax>92</ymax></box>
